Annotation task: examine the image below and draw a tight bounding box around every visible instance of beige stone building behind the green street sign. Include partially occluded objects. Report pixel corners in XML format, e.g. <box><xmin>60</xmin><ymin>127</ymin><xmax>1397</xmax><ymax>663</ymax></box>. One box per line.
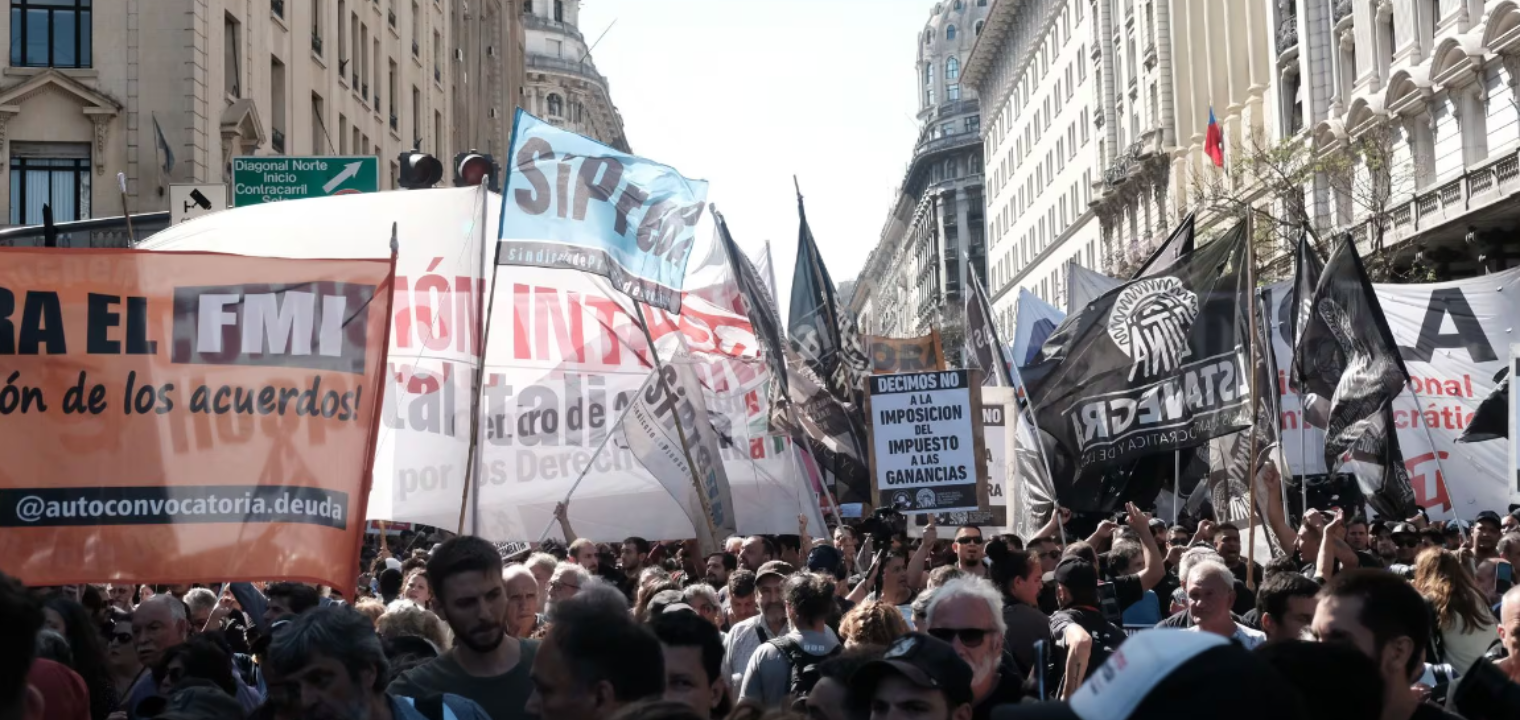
<box><xmin>0</xmin><ymin>0</ymin><xmax>524</xmax><ymax>232</ymax></box>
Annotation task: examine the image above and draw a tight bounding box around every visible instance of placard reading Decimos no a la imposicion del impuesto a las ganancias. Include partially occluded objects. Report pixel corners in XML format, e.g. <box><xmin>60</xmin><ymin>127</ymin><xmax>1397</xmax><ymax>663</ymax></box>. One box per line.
<box><xmin>866</xmin><ymin>371</ymin><xmax>988</xmax><ymax>513</ymax></box>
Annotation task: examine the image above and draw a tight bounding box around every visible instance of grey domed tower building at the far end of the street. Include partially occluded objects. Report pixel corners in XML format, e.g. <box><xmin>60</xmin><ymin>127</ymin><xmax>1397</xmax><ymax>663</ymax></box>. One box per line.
<box><xmin>850</xmin><ymin>0</ymin><xmax>990</xmax><ymax>357</ymax></box>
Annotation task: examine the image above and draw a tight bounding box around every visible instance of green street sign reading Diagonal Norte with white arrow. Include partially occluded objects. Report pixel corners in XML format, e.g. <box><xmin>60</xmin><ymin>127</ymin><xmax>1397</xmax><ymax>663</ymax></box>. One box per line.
<box><xmin>233</xmin><ymin>155</ymin><xmax>380</xmax><ymax>208</ymax></box>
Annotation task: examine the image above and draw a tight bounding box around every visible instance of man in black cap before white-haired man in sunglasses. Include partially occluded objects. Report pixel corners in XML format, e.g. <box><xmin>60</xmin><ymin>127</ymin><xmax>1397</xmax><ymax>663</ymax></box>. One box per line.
<box><xmin>850</xmin><ymin>632</ymin><xmax>971</xmax><ymax>720</ymax></box>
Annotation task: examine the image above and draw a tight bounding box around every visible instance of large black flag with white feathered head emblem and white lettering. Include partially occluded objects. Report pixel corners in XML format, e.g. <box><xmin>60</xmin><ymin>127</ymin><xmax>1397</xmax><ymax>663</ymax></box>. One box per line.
<box><xmin>1024</xmin><ymin>223</ymin><xmax>1252</xmax><ymax>512</ymax></box>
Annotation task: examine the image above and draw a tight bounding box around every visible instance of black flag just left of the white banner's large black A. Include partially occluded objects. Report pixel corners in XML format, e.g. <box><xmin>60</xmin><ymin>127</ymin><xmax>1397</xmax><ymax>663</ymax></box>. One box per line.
<box><xmin>1294</xmin><ymin>234</ymin><xmax>1415</xmax><ymax>518</ymax></box>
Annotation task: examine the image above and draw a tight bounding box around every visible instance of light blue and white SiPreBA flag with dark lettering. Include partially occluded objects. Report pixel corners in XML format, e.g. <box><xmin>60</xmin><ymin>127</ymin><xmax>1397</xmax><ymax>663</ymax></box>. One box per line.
<box><xmin>496</xmin><ymin>109</ymin><xmax>707</xmax><ymax>311</ymax></box>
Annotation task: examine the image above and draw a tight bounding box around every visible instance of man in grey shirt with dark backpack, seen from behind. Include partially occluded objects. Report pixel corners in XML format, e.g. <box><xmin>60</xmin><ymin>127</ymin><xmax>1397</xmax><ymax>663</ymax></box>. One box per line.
<box><xmin>739</xmin><ymin>573</ymin><xmax>841</xmax><ymax>708</ymax></box>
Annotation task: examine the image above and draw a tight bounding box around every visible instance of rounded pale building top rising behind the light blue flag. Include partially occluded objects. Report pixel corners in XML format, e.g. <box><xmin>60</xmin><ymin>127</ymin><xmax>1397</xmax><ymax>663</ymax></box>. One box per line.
<box><xmin>515</xmin><ymin>0</ymin><xmax>629</xmax><ymax>152</ymax></box>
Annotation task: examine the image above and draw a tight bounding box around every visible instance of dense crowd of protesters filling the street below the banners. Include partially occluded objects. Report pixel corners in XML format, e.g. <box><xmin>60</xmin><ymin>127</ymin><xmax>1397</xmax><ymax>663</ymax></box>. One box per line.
<box><xmin>0</xmin><ymin>504</ymin><xmax>1520</xmax><ymax>720</ymax></box>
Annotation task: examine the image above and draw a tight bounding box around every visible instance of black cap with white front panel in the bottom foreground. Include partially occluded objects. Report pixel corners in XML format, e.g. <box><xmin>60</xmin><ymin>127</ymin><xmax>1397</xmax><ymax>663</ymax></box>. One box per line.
<box><xmin>993</xmin><ymin>629</ymin><xmax>1309</xmax><ymax>720</ymax></box>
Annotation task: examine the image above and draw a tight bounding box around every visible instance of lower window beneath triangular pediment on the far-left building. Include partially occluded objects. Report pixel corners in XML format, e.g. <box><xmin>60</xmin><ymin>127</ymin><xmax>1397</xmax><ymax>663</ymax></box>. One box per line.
<box><xmin>11</xmin><ymin>143</ymin><xmax>90</xmax><ymax>225</ymax></box>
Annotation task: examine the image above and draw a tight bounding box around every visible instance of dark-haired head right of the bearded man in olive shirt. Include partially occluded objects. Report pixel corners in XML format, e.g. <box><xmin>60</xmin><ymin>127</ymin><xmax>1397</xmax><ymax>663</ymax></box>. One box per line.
<box><xmin>525</xmin><ymin>597</ymin><xmax>666</xmax><ymax>720</ymax></box>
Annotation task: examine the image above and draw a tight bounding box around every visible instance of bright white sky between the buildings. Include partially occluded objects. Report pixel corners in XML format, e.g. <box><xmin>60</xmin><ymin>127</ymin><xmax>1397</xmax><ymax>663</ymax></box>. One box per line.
<box><xmin>579</xmin><ymin>0</ymin><xmax>933</xmax><ymax>314</ymax></box>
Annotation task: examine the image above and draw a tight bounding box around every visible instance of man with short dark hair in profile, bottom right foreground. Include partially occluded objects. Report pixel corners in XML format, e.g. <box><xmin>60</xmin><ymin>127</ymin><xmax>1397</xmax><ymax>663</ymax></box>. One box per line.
<box><xmin>1313</xmin><ymin>570</ymin><xmax>1456</xmax><ymax>720</ymax></box>
